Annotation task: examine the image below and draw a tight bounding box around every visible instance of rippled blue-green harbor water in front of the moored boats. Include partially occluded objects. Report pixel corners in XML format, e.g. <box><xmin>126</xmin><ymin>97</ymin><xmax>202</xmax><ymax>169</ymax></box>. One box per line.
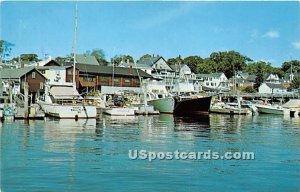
<box><xmin>0</xmin><ymin>114</ymin><xmax>300</xmax><ymax>192</ymax></box>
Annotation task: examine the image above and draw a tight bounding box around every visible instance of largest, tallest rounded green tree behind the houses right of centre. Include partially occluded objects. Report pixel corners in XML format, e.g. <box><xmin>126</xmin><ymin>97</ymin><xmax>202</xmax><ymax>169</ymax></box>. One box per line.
<box><xmin>210</xmin><ymin>51</ymin><xmax>252</xmax><ymax>78</ymax></box>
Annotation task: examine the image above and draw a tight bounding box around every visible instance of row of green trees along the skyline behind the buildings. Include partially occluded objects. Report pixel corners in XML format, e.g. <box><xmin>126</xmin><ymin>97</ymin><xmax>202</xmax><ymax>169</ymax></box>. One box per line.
<box><xmin>0</xmin><ymin>40</ymin><xmax>300</xmax><ymax>89</ymax></box>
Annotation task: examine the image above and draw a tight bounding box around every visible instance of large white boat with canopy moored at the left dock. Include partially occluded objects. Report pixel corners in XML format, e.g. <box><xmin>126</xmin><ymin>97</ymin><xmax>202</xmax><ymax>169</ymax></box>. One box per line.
<box><xmin>37</xmin><ymin>83</ymin><xmax>97</xmax><ymax>119</ymax></box>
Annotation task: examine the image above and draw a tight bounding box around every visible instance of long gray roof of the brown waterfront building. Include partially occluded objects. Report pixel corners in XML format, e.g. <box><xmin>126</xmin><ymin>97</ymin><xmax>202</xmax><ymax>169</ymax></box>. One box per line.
<box><xmin>76</xmin><ymin>64</ymin><xmax>153</xmax><ymax>78</ymax></box>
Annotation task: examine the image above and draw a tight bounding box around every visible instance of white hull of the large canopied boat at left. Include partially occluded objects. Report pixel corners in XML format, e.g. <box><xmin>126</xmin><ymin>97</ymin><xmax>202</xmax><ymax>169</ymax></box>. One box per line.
<box><xmin>38</xmin><ymin>101</ymin><xmax>97</xmax><ymax>119</ymax></box>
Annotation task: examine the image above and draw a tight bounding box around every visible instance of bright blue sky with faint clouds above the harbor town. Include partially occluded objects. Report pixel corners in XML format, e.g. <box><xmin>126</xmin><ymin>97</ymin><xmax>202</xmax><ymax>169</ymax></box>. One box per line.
<box><xmin>0</xmin><ymin>1</ymin><xmax>300</xmax><ymax>66</ymax></box>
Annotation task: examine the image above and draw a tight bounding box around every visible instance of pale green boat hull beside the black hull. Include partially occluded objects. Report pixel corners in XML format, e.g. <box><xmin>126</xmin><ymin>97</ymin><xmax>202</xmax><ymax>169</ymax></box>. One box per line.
<box><xmin>148</xmin><ymin>97</ymin><xmax>175</xmax><ymax>113</ymax></box>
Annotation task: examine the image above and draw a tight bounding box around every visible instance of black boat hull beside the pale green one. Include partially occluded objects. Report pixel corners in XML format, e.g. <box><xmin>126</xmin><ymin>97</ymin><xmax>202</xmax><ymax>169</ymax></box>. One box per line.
<box><xmin>174</xmin><ymin>97</ymin><xmax>212</xmax><ymax>116</ymax></box>
